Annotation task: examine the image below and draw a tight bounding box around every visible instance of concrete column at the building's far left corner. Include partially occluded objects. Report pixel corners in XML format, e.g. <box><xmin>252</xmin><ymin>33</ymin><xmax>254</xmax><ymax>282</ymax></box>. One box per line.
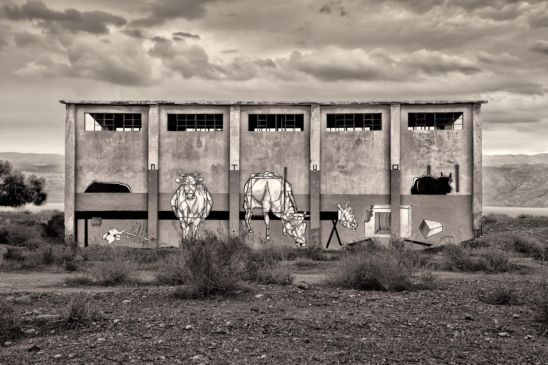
<box><xmin>65</xmin><ymin>104</ymin><xmax>77</xmax><ymax>246</ymax></box>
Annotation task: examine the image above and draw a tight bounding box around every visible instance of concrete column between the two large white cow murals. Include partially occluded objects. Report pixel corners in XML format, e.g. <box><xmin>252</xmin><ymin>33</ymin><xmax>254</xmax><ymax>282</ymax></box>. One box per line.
<box><xmin>228</xmin><ymin>105</ymin><xmax>240</xmax><ymax>236</ymax></box>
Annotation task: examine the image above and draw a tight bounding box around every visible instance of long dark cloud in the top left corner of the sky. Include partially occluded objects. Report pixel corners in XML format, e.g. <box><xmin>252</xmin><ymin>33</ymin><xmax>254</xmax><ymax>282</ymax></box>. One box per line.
<box><xmin>0</xmin><ymin>0</ymin><xmax>127</xmax><ymax>34</ymax></box>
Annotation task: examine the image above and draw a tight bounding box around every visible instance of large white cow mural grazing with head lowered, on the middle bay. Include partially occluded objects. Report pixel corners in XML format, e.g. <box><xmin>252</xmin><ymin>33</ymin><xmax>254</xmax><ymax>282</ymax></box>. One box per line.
<box><xmin>244</xmin><ymin>171</ymin><xmax>306</xmax><ymax>247</ymax></box>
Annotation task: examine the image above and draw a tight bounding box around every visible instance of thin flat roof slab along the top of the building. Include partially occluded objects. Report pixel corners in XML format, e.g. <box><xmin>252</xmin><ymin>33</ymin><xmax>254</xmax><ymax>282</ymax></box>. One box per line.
<box><xmin>59</xmin><ymin>100</ymin><xmax>487</xmax><ymax>106</ymax></box>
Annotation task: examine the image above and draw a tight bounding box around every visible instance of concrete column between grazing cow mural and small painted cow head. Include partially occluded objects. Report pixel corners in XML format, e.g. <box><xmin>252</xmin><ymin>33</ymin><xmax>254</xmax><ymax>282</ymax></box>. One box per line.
<box><xmin>309</xmin><ymin>104</ymin><xmax>322</xmax><ymax>247</ymax></box>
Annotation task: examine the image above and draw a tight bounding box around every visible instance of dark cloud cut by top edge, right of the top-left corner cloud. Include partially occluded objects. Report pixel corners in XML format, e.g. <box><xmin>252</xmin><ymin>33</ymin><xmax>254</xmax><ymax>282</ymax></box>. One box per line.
<box><xmin>131</xmin><ymin>0</ymin><xmax>217</xmax><ymax>27</ymax></box>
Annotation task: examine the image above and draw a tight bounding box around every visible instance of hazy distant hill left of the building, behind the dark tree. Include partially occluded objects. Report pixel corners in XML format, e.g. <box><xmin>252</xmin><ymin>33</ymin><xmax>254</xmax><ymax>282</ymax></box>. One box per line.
<box><xmin>0</xmin><ymin>152</ymin><xmax>65</xmax><ymax>203</ymax></box>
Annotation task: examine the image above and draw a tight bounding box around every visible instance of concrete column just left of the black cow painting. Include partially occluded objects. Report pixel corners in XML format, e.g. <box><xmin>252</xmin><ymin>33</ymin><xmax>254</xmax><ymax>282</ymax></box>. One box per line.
<box><xmin>389</xmin><ymin>104</ymin><xmax>401</xmax><ymax>239</ymax></box>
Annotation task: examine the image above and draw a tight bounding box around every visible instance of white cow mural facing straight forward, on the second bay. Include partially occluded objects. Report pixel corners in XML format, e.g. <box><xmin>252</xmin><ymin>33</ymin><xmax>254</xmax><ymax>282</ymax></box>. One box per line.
<box><xmin>171</xmin><ymin>174</ymin><xmax>213</xmax><ymax>241</ymax></box>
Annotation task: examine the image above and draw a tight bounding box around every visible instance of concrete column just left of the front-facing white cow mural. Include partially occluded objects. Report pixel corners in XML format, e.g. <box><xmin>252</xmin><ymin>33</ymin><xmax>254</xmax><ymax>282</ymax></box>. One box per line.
<box><xmin>147</xmin><ymin>105</ymin><xmax>160</xmax><ymax>247</ymax></box>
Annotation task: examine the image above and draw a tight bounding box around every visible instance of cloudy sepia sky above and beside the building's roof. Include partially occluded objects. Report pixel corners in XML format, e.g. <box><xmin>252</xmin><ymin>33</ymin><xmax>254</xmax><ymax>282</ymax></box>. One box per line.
<box><xmin>0</xmin><ymin>0</ymin><xmax>548</xmax><ymax>154</ymax></box>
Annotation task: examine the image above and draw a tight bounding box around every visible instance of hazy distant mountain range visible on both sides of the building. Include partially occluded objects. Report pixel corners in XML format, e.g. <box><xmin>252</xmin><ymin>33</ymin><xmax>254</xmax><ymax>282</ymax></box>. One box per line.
<box><xmin>0</xmin><ymin>152</ymin><xmax>548</xmax><ymax>207</ymax></box>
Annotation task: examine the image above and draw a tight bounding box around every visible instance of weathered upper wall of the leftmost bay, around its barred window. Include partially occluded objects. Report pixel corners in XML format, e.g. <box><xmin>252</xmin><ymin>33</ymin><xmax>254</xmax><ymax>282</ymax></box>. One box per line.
<box><xmin>75</xmin><ymin>105</ymin><xmax>148</xmax><ymax>193</ymax></box>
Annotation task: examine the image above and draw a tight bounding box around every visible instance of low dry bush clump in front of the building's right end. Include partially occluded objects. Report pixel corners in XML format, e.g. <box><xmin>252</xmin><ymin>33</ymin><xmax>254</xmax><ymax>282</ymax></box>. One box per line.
<box><xmin>441</xmin><ymin>245</ymin><xmax>515</xmax><ymax>273</ymax></box>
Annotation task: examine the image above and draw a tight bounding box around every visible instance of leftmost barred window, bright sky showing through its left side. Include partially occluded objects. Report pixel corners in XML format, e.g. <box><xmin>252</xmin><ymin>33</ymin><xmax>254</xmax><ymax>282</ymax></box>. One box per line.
<box><xmin>84</xmin><ymin>113</ymin><xmax>143</xmax><ymax>132</ymax></box>
